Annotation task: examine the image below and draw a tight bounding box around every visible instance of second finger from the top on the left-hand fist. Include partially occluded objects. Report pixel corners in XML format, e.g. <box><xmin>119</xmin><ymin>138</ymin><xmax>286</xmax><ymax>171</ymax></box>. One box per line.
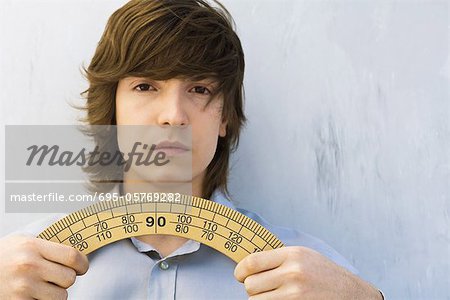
<box><xmin>39</xmin><ymin>260</ymin><xmax>77</xmax><ymax>289</ymax></box>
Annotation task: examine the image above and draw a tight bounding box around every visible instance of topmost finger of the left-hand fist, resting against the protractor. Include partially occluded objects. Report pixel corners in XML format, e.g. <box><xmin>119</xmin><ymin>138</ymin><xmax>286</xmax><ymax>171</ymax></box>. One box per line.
<box><xmin>37</xmin><ymin>239</ymin><xmax>89</xmax><ymax>275</ymax></box>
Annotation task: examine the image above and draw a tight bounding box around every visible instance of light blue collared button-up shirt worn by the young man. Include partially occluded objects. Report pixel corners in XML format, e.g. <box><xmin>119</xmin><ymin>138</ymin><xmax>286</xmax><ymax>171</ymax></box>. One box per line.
<box><xmin>15</xmin><ymin>191</ymin><xmax>357</xmax><ymax>300</ymax></box>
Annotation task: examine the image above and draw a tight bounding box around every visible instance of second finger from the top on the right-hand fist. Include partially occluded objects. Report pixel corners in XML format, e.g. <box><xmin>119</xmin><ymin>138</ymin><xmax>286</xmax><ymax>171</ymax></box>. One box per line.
<box><xmin>244</xmin><ymin>269</ymin><xmax>283</xmax><ymax>296</ymax></box>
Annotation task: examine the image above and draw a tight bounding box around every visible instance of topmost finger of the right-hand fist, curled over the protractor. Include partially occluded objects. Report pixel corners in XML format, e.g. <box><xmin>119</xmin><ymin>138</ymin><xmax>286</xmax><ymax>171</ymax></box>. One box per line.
<box><xmin>234</xmin><ymin>248</ymin><xmax>286</xmax><ymax>282</ymax></box>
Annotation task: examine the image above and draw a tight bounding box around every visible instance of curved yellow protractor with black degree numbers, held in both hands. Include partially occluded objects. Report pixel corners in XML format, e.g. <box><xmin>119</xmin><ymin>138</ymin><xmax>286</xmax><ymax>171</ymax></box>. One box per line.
<box><xmin>38</xmin><ymin>193</ymin><xmax>284</xmax><ymax>262</ymax></box>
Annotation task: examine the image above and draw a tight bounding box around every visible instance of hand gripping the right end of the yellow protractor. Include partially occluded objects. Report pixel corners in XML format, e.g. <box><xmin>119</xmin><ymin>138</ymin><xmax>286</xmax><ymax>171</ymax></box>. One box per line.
<box><xmin>234</xmin><ymin>246</ymin><xmax>382</xmax><ymax>300</ymax></box>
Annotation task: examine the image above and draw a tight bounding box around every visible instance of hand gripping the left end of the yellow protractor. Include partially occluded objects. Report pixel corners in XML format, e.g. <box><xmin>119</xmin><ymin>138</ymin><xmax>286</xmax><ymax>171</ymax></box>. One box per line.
<box><xmin>0</xmin><ymin>235</ymin><xmax>89</xmax><ymax>299</ymax></box>
